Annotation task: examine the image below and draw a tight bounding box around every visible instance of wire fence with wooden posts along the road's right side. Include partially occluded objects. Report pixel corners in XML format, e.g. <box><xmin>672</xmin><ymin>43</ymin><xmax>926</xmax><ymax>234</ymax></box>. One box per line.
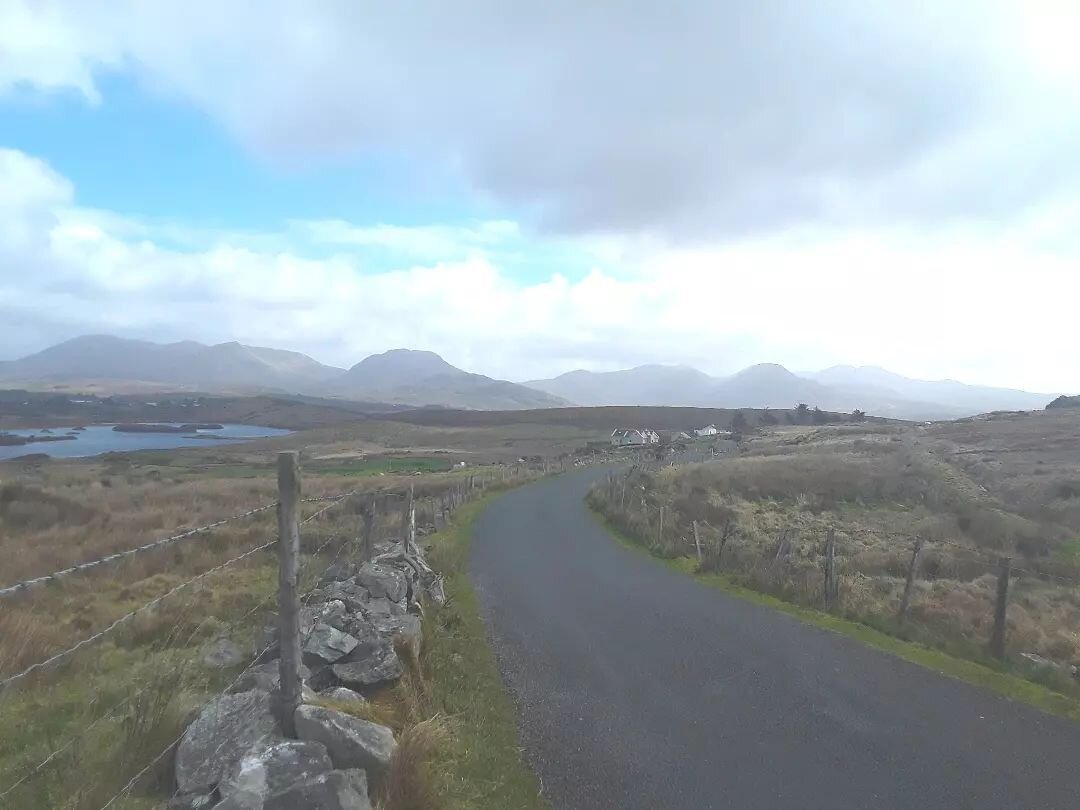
<box><xmin>590</xmin><ymin>460</ymin><xmax>1080</xmax><ymax>677</ymax></box>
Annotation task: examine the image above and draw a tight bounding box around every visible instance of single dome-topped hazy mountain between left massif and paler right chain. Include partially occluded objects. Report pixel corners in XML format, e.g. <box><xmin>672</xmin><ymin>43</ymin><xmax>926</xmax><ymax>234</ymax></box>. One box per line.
<box><xmin>327</xmin><ymin>349</ymin><xmax>566</xmax><ymax>410</ymax></box>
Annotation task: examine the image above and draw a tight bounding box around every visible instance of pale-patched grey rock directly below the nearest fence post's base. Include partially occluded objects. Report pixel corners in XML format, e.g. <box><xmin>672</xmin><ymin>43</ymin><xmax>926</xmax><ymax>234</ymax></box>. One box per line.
<box><xmin>217</xmin><ymin>740</ymin><xmax>334</xmax><ymax>805</ymax></box>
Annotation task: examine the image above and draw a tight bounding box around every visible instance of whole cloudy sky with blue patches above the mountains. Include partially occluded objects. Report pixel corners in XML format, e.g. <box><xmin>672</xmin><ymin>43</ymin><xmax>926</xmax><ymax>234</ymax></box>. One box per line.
<box><xmin>0</xmin><ymin>0</ymin><xmax>1080</xmax><ymax>392</ymax></box>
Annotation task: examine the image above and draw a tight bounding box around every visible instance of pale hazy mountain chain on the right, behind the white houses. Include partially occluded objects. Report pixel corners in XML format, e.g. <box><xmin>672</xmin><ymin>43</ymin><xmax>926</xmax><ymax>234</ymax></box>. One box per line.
<box><xmin>525</xmin><ymin>363</ymin><xmax>1050</xmax><ymax>419</ymax></box>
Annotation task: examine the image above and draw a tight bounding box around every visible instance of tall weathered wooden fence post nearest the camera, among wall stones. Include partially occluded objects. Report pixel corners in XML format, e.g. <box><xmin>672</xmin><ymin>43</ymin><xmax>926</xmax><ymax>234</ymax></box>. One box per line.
<box><xmin>276</xmin><ymin>450</ymin><xmax>301</xmax><ymax>737</ymax></box>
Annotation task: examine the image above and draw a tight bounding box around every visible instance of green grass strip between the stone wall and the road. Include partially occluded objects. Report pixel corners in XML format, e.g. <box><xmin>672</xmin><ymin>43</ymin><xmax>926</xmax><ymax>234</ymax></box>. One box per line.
<box><xmin>424</xmin><ymin>495</ymin><xmax>548</xmax><ymax>810</ymax></box>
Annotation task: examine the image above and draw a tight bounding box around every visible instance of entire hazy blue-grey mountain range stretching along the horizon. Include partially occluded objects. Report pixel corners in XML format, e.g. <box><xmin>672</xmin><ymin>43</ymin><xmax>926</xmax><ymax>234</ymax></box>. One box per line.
<box><xmin>0</xmin><ymin>335</ymin><xmax>1054</xmax><ymax>419</ymax></box>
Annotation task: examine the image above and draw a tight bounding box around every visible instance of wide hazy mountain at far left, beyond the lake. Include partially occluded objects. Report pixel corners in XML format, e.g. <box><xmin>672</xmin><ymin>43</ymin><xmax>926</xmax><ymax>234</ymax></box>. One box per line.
<box><xmin>0</xmin><ymin>335</ymin><xmax>342</xmax><ymax>391</ymax></box>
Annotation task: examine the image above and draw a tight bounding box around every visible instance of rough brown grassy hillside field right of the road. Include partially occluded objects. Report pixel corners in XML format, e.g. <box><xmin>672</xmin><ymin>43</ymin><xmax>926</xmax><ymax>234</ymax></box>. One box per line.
<box><xmin>594</xmin><ymin>413</ymin><xmax>1080</xmax><ymax>694</ymax></box>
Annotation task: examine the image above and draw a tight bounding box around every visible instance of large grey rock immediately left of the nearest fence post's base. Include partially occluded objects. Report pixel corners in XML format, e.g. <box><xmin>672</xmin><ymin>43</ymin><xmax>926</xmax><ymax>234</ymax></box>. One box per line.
<box><xmin>176</xmin><ymin>689</ymin><xmax>282</xmax><ymax>793</ymax></box>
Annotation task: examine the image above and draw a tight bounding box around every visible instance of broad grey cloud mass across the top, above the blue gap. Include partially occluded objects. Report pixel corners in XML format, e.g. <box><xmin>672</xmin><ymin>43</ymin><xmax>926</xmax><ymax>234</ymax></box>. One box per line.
<box><xmin>0</xmin><ymin>0</ymin><xmax>1080</xmax><ymax>244</ymax></box>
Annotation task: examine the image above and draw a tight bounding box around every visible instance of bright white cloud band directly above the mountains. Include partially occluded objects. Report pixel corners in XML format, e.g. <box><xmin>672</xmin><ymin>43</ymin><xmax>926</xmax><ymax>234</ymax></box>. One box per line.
<box><xmin>0</xmin><ymin>150</ymin><xmax>1080</xmax><ymax>391</ymax></box>
